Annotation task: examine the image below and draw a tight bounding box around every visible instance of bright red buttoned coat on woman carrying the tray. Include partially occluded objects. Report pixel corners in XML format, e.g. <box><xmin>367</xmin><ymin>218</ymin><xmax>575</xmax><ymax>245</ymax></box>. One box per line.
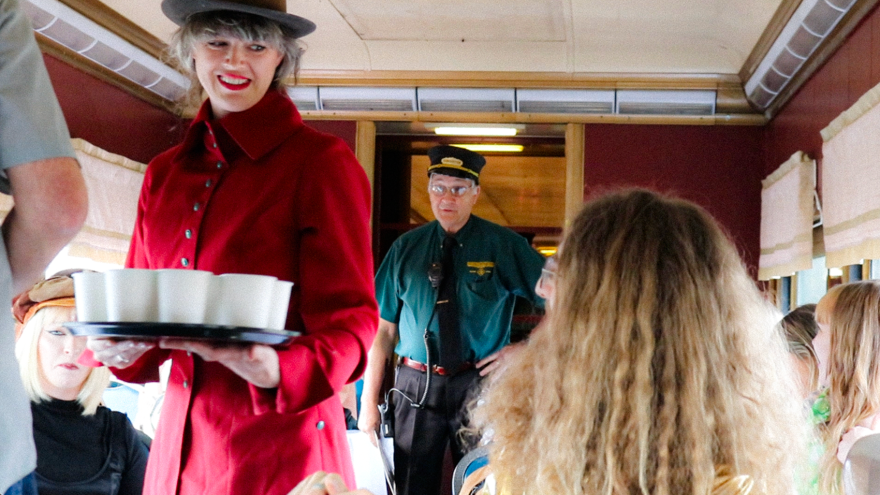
<box><xmin>115</xmin><ymin>90</ymin><xmax>378</xmax><ymax>495</ymax></box>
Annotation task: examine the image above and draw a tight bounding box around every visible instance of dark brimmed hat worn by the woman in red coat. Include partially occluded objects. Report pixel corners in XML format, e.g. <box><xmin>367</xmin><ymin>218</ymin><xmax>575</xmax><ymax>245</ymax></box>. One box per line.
<box><xmin>162</xmin><ymin>0</ymin><xmax>315</xmax><ymax>38</ymax></box>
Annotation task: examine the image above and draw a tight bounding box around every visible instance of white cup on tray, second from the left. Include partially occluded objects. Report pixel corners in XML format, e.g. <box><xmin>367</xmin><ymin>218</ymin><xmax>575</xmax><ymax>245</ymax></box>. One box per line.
<box><xmin>104</xmin><ymin>269</ymin><xmax>159</xmax><ymax>322</ymax></box>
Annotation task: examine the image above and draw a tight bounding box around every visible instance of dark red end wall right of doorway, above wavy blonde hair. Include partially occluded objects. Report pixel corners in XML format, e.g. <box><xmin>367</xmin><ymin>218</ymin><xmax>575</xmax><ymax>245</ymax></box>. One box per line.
<box><xmin>584</xmin><ymin>124</ymin><xmax>764</xmax><ymax>274</ymax></box>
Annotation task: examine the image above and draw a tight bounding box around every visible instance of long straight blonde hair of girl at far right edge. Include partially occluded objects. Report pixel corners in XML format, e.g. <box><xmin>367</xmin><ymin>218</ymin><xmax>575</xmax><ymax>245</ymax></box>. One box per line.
<box><xmin>821</xmin><ymin>280</ymin><xmax>880</xmax><ymax>494</ymax></box>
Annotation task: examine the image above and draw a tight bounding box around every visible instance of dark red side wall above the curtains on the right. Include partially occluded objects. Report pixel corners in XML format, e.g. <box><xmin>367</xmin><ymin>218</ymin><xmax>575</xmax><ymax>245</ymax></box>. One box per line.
<box><xmin>764</xmin><ymin>3</ymin><xmax>880</xmax><ymax>175</ymax></box>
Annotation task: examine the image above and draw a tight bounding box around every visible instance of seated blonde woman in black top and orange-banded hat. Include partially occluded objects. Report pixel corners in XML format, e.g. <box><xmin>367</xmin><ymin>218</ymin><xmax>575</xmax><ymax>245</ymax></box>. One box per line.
<box><xmin>13</xmin><ymin>275</ymin><xmax>148</xmax><ymax>495</ymax></box>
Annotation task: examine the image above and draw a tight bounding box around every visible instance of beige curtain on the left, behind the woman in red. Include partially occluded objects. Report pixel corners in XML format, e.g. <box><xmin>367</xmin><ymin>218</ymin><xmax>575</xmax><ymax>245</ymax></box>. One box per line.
<box><xmin>0</xmin><ymin>139</ymin><xmax>147</xmax><ymax>265</ymax></box>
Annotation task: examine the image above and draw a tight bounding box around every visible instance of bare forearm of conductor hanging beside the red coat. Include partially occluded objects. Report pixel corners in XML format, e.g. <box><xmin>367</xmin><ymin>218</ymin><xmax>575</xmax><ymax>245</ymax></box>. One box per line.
<box><xmin>358</xmin><ymin>318</ymin><xmax>397</xmax><ymax>434</ymax></box>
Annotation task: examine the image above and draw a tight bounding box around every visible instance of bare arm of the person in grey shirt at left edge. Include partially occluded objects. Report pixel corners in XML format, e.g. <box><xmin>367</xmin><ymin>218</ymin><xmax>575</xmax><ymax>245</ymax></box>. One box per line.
<box><xmin>3</xmin><ymin>157</ymin><xmax>88</xmax><ymax>294</ymax></box>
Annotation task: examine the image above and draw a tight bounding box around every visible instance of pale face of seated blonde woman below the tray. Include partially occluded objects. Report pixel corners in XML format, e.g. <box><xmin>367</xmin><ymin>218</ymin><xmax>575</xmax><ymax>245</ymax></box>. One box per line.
<box><xmin>37</xmin><ymin>308</ymin><xmax>91</xmax><ymax>400</ymax></box>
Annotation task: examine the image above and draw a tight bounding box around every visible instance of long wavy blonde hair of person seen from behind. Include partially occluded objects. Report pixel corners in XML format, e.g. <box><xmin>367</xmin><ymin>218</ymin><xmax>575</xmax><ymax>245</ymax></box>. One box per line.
<box><xmin>472</xmin><ymin>190</ymin><xmax>806</xmax><ymax>495</ymax></box>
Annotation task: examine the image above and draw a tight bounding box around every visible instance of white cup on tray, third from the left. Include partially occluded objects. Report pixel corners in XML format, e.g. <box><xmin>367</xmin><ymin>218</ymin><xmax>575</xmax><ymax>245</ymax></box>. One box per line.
<box><xmin>156</xmin><ymin>269</ymin><xmax>214</xmax><ymax>324</ymax></box>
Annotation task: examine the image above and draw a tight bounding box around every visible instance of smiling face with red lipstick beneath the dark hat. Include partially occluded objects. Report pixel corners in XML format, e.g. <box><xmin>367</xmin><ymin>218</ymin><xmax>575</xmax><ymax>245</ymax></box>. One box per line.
<box><xmin>192</xmin><ymin>36</ymin><xmax>284</xmax><ymax>119</ymax></box>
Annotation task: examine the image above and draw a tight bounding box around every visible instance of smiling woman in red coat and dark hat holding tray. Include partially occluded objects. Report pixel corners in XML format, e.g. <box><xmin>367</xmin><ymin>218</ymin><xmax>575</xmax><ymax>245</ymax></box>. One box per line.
<box><xmin>89</xmin><ymin>0</ymin><xmax>378</xmax><ymax>495</ymax></box>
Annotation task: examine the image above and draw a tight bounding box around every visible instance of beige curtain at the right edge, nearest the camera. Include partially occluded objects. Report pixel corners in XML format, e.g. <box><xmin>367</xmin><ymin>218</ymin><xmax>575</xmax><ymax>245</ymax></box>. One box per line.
<box><xmin>822</xmin><ymin>81</ymin><xmax>880</xmax><ymax>267</ymax></box>
